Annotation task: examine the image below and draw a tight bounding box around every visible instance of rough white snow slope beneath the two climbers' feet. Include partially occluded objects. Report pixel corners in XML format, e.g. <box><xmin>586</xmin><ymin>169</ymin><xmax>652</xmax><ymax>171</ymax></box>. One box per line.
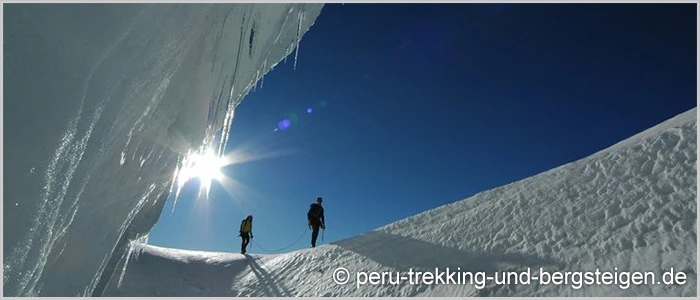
<box><xmin>106</xmin><ymin>109</ymin><xmax>697</xmax><ymax>296</ymax></box>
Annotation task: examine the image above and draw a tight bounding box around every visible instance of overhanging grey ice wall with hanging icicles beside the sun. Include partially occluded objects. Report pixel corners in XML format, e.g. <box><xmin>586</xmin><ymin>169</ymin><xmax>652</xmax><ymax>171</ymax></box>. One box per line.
<box><xmin>3</xmin><ymin>4</ymin><xmax>323</xmax><ymax>296</ymax></box>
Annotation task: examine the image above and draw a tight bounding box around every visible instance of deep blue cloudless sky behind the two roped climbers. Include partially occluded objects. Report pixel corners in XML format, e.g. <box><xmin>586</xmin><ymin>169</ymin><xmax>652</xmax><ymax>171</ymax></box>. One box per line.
<box><xmin>149</xmin><ymin>4</ymin><xmax>697</xmax><ymax>253</ymax></box>
